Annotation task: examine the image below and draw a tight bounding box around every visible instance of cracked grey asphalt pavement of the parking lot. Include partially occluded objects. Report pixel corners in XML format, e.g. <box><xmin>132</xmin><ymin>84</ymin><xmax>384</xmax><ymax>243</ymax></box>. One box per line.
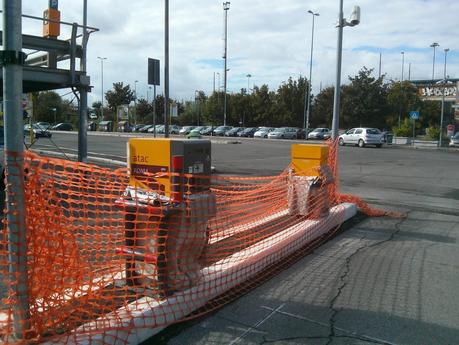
<box><xmin>30</xmin><ymin>134</ymin><xmax>459</xmax><ymax>345</ymax></box>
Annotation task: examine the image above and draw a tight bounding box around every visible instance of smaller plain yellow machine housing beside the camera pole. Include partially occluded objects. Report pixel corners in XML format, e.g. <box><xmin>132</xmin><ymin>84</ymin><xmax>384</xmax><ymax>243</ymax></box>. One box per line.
<box><xmin>292</xmin><ymin>144</ymin><xmax>329</xmax><ymax>176</ymax></box>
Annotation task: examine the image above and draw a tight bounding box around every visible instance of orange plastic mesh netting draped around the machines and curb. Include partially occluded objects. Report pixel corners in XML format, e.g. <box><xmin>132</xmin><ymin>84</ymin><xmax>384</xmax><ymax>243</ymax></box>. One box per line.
<box><xmin>0</xmin><ymin>140</ymin><xmax>396</xmax><ymax>344</ymax></box>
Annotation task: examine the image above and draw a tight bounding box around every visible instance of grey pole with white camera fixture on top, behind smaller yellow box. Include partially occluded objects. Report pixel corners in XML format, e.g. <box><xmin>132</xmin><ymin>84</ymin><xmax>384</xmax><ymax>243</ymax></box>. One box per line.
<box><xmin>332</xmin><ymin>0</ymin><xmax>360</xmax><ymax>140</ymax></box>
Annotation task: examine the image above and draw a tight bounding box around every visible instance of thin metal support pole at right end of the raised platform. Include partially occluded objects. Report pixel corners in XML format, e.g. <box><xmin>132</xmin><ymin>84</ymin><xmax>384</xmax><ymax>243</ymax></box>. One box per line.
<box><xmin>78</xmin><ymin>0</ymin><xmax>89</xmax><ymax>162</ymax></box>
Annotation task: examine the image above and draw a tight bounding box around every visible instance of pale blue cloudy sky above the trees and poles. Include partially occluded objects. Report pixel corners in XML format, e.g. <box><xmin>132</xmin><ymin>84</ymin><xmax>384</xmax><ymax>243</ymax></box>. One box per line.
<box><xmin>16</xmin><ymin>0</ymin><xmax>459</xmax><ymax>103</ymax></box>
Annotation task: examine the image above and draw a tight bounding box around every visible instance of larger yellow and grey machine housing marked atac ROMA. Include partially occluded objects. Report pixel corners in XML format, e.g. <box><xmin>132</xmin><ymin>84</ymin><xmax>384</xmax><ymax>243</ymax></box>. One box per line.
<box><xmin>127</xmin><ymin>138</ymin><xmax>211</xmax><ymax>197</ymax></box>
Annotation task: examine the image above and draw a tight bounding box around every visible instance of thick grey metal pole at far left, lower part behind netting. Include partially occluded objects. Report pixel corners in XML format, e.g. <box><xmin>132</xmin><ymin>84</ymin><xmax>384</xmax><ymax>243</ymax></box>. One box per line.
<box><xmin>3</xmin><ymin>0</ymin><xmax>30</xmax><ymax>339</ymax></box>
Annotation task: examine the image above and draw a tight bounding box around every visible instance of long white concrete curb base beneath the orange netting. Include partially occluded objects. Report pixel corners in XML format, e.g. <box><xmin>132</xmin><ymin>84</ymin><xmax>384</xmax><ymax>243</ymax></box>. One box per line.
<box><xmin>46</xmin><ymin>203</ymin><xmax>357</xmax><ymax>344</ymax></box>
